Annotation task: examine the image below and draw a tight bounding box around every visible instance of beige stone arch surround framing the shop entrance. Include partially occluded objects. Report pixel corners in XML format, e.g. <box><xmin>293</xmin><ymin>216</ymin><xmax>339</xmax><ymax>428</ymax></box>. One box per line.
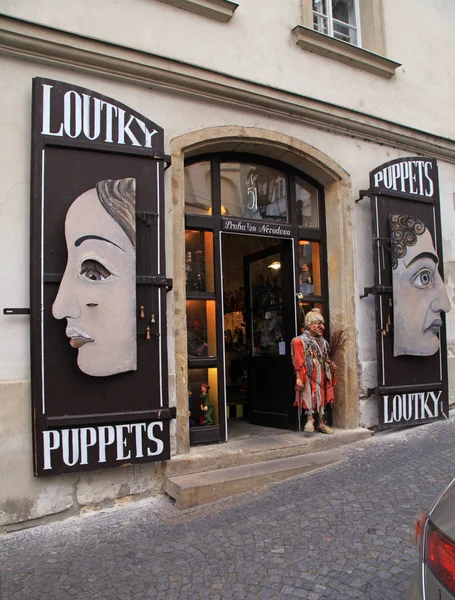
<box><xmin>171</xmin><ymin>127</ymin><xmax>358</xmax><ymax>452</ymax></box>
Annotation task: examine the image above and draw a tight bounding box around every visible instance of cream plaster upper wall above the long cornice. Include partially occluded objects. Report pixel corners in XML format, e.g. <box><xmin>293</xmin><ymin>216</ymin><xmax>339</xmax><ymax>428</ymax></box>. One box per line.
<box><xmin>1</xmin><ymin>0</ymin><xmax>455</xmax><ymax>137</ymax></box>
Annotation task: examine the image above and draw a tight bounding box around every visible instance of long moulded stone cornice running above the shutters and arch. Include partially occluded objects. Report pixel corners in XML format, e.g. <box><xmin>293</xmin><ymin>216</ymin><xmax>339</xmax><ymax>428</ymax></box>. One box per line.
<box><xmin>0</xmin><ymin>15</ymin><xmax>455</xmax><ymax>163</ymax></box>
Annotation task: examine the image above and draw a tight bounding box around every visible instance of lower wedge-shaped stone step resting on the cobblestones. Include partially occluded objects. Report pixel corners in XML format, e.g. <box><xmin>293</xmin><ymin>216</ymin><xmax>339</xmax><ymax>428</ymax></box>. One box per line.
<box><xmin>164</xmin><ymin>450</ymin><xmax>343</xmax><ymax>509</ymax></box>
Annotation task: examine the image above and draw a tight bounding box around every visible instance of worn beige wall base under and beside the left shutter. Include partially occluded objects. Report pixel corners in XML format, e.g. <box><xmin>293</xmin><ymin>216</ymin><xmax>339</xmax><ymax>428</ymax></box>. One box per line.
<box><xmin>0</xmin><ymin>381</ymin><xmax>162</xmax><ymax>531</ymax></box>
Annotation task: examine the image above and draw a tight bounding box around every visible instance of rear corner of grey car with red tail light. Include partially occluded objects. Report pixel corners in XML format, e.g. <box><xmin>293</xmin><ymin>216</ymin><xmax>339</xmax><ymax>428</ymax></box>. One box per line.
<box><xmin>405</xmin><ymin>479</ymin><xmax>455</xmax><ymax>600</ymax></box>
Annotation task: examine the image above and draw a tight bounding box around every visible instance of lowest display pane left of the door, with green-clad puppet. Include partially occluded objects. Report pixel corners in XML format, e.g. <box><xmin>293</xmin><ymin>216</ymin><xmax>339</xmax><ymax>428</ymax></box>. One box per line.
<box><xmin>188</xmin><ymin>368</ymin><xmax>219</xmax><ymax>428</ymax></box>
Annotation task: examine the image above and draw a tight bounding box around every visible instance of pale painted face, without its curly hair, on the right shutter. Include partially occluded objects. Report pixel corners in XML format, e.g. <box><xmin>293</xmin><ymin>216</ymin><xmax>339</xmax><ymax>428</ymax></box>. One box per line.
<box><xmin>392</xmin><ymin>224</ymin><xmax>450</xmax><ymax>356</ymax></box>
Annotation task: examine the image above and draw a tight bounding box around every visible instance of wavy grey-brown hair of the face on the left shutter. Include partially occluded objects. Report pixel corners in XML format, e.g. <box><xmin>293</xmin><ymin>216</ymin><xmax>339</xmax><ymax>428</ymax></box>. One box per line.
<box><xmin>96</xmin><ymin>177</ymin><xmax>136</xmax><ymax>248</ymax></box>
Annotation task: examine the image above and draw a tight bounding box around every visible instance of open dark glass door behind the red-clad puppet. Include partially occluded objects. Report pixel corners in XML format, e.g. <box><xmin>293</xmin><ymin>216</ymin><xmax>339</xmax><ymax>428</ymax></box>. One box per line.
<box><xmin>244</xmin><ymin>241</ymin><xmax>295</xmax><ymax>428</ymax></box>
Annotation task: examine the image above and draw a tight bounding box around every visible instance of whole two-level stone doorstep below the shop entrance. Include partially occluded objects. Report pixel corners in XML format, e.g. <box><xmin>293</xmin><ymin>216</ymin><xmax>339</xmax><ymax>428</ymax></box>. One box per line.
<box><xmin>163</xmin><ymin>427</ymin><xmax>373</xmax><ymax>509</ymax></box>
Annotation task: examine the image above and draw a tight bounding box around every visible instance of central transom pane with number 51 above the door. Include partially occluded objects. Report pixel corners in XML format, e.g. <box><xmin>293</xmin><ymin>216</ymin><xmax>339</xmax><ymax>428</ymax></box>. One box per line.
<box><xmin>220</xmin><ymin>162</ymin><xmax>288</xmax><ymax>223</ymax></box>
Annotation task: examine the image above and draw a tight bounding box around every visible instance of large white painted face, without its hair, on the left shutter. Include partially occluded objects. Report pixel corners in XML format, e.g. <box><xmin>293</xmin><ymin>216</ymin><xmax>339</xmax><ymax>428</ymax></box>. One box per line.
<box><xmin>52</xmin><ymin>189</ymin><xmax>137</xmax><ymax>377</ymax></box>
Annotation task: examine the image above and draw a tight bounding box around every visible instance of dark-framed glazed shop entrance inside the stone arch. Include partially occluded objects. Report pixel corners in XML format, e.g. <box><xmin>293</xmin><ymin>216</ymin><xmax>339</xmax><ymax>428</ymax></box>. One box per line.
<box><xmin>185</xmin><ymin>153</ymin><xmax>329</xmax><ymax>444</ymax></box>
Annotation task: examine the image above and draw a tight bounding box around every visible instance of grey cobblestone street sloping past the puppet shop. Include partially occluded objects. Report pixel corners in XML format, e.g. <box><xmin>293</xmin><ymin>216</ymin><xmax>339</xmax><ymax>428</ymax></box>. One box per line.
<box><xmin>0</xmin><ymin>420</ymin><xmax>455</xmax><ymax>600</ymax></box>
